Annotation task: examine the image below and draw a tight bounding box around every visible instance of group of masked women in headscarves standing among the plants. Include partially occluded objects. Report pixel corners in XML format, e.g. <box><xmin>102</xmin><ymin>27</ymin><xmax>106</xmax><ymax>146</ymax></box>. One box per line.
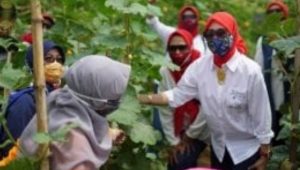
<box><xmin>0</xmin><ymin>0</ymin><xmax>290</xmax><ymax>170</ymax></box>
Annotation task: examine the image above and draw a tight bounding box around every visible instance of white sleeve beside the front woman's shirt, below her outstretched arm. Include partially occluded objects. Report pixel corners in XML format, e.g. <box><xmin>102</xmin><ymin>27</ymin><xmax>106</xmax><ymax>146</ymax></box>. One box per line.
<box><xmin>185</xmin><ymin>107</ymin><xmax>210</xmax><ymax>143</ymax></box>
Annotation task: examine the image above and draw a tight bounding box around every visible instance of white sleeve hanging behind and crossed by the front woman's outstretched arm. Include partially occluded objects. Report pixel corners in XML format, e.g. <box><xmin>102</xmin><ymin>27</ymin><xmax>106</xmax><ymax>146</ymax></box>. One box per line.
<box><xmin>159</xmin><ymin>68</ymin><xmax>180</xmax><ymax>145</ymax></box>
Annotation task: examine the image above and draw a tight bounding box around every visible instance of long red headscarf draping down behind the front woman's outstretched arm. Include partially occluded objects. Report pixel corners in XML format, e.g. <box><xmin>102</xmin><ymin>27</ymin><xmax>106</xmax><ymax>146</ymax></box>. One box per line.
<box><xmin>168</xmin><ymin>29</ymin><xmax>200</xmax><ymax>136</ymax></box>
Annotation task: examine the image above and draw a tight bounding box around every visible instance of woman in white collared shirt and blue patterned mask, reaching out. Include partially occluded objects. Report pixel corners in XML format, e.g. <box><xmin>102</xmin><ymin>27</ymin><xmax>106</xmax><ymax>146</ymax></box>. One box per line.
<box><xmin>138</xmin><ymin>12</ymin><xmax>273</xmax><ymax>170</ymax></box>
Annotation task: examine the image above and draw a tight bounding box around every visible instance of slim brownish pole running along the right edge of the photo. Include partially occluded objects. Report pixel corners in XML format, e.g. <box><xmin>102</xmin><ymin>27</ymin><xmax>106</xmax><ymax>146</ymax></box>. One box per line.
<box><xmin>290</xmin><ymin>0</ymin><xmax>300</xmax><ymax>170</ymax></box>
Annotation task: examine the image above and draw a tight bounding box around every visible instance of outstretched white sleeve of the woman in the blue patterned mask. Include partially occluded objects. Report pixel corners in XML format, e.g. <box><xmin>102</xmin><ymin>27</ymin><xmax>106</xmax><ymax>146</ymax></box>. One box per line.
<box><xmin>163</xmin><ymin>60</ymin><xmax>199</xmax><ymax>108</ymax></box>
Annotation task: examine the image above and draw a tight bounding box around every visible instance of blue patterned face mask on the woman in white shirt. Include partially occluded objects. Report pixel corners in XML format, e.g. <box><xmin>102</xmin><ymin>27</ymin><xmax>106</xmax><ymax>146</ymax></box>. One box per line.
<box><xmin>207</xmin><ymin>35</ymin><xmax>232</xmax><ymax>57</ymax></box>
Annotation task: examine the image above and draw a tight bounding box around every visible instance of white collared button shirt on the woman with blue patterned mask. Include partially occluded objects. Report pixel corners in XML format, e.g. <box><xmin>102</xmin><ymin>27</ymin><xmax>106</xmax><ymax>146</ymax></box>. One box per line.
<box><xmin>164</xmin><ymin>51</ymin><xmax>273</xmax><ymax>164</ymax></box>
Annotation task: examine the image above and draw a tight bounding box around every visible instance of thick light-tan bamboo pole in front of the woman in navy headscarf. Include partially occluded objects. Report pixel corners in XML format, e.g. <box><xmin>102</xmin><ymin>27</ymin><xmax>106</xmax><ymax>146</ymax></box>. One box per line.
<box><xmin>31</xmin><ymin>0</ymin><xmax>49</xmax><ymax>170</ymax></box>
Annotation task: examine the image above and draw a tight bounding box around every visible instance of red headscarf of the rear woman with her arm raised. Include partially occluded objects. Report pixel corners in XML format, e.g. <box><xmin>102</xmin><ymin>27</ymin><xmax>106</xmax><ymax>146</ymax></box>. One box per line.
<box><xmin>177</xmin><ymin>6</ymin><xmax>200</xmax><ymax>37</ymax></box>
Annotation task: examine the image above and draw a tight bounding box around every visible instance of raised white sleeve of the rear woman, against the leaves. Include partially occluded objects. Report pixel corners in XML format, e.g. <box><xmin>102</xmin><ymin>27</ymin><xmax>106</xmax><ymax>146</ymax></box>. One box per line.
<box><xmin>147</xmin><ymin>16</ymin><xmax>176</xmax><ymax>46</ymax></box>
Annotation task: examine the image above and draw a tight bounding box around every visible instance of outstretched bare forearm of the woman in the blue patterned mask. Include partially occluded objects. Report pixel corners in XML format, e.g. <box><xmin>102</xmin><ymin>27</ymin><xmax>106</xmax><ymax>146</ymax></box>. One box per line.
<box><xmin>138</xmin><ymin>93</ymin><xmax>169</xmax><ymax>105</ymax></box>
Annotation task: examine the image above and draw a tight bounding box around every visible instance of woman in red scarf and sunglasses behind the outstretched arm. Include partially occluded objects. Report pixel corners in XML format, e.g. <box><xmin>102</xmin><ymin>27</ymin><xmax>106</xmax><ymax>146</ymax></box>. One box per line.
<box><xmin>159</xmin><ymin>29</ymin><xmax>209</xmax><ymax>170</ymax></box>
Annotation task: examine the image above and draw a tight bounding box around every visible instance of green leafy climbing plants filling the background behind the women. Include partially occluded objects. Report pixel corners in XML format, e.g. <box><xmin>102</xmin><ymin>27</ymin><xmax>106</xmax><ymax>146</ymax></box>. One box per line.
<box><xmin>0</xmin><ymin>0</ymin><xmax>300</xmax><ymax>170</ymax></box>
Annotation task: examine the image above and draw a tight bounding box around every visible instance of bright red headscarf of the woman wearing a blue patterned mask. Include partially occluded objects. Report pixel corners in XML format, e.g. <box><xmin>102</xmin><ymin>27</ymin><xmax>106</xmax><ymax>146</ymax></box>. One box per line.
<box><xmin>205</xmin><ymin>12</ymin><xmax>247</xmax><ymax>67</ymax></box>
